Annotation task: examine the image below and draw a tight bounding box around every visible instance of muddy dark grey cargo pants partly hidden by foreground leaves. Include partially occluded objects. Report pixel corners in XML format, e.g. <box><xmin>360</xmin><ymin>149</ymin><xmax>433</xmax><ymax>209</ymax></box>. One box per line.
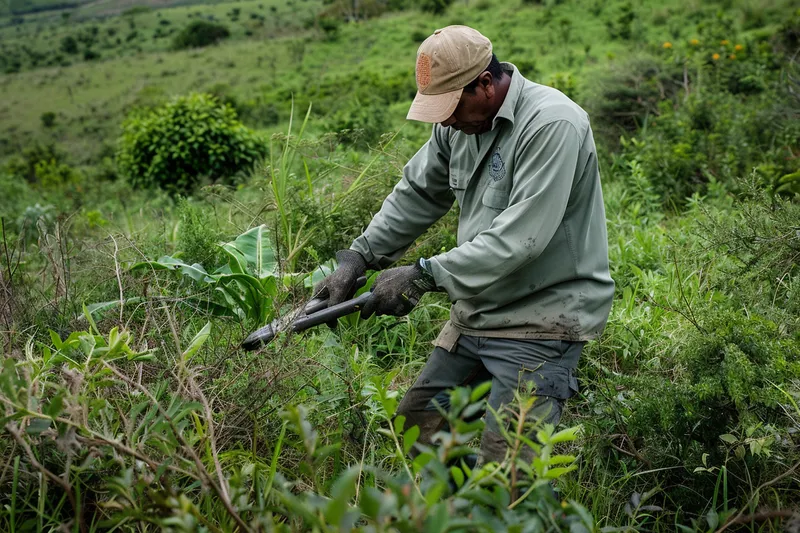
<box><xmin>397</xmin><ymin>335</ymin><xmax>586</xmax><ymax>462</ymax></box>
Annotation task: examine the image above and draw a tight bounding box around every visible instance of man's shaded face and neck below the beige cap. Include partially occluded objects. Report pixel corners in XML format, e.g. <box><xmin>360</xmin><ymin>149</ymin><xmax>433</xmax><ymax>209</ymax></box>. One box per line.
<box><xmin>440</xmin><ymin>70</ymin><xmax>511</xmax><ymax>135</ymax></box>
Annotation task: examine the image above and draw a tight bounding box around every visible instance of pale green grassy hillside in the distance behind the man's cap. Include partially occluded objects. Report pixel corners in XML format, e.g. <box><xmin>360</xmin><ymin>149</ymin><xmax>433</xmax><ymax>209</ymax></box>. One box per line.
<box><xmin>0</xmin><ymin>0</ymin><xmax>780</xmax><ymax>163</ymax></box>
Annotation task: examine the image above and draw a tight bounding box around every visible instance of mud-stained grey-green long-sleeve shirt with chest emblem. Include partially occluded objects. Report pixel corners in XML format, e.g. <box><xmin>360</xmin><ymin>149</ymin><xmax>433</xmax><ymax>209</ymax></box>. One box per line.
<box><xmin>351</xmin><ymin>63</ymin><xmax>614</xmax><ymax>341</ymax></box>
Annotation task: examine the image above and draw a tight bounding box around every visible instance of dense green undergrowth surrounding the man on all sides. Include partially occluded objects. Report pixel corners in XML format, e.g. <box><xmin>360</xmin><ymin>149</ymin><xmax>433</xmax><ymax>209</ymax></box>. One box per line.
<box><xmin>0</xmin><ymin>1</ymin><xmax>800</xmax><ymax>532</ymax></box>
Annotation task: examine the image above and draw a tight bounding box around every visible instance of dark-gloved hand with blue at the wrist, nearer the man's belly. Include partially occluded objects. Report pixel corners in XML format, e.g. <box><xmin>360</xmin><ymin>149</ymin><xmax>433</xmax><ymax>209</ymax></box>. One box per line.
<box><xmin>361</xmin><ymin>263</ymin><xmax>436</xmax><ymax>318</ymax></box>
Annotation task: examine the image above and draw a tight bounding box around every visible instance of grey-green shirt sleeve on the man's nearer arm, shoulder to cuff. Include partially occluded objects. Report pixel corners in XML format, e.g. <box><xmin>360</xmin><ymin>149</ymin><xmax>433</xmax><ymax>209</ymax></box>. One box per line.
<box><xmin>430</xmin><ymin>120</ymin><xmax>581</xmax><ymax>301</ymax></box>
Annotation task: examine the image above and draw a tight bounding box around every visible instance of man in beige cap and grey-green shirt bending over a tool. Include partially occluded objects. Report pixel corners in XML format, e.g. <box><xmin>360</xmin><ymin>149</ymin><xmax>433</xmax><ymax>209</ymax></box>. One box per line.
<box><xmin>318</xmin><ymin>26</ymin><xmax>614</xmax><ymax>461</ymax></box>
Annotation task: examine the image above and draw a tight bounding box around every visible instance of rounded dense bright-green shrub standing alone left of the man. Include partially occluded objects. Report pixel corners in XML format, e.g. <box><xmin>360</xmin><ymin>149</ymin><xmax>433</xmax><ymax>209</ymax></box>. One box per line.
<box><xmin>117</xmin><ymin>94</ymin><xmax>265</xmax><ymax>194</ymax></box>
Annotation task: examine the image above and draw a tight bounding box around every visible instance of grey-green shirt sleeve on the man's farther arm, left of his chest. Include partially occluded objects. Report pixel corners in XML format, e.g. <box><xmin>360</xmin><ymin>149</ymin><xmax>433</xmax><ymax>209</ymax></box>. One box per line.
<box><xmin>350</xmin><ymin>125</ymin><xmax>455</xmax><ymax>268</ymax></box>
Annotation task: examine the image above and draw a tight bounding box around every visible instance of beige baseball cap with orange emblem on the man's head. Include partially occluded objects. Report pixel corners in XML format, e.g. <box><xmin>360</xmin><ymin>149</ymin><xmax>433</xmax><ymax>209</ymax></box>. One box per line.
<box><xmin>406</xmin><ymin>26</ymin><xmax>492</xmax><ymax>123</ymax></box>
